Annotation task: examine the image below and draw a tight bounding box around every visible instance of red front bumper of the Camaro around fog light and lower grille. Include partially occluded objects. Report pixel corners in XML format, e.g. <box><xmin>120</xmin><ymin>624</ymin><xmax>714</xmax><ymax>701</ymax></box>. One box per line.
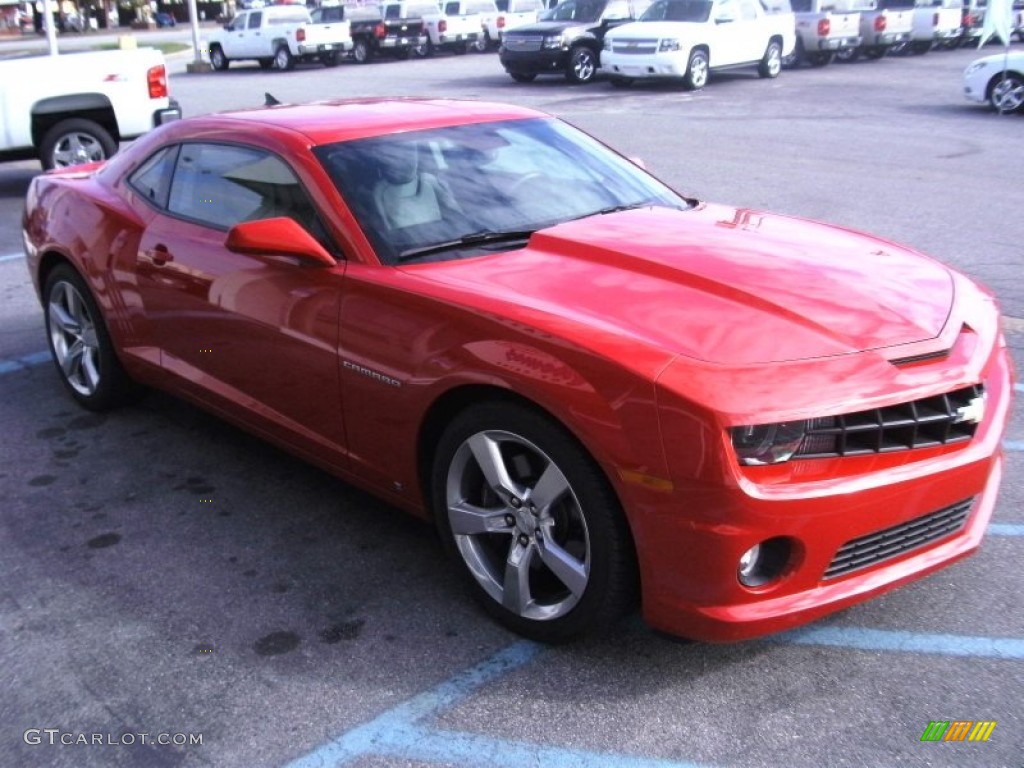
<box><xmin>628</xmin><ymin>335</ymin><xmax>1013</xmax><ymax>642</ymax></box>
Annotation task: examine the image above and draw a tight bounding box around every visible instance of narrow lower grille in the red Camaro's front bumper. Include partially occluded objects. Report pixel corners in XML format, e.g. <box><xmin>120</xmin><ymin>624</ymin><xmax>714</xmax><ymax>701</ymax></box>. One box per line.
<box><xmin>822</xmin><ymin>499</ymin><xmax>974</xmax><ymax>581</ymax></box>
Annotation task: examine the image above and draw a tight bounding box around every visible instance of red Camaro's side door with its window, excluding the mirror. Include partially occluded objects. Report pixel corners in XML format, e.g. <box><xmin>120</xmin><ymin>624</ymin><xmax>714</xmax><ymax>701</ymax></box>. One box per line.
<box><xmin>129</xmin><ymin>142</ymin><xmax>345</xmax><ymax>463</ymax></box>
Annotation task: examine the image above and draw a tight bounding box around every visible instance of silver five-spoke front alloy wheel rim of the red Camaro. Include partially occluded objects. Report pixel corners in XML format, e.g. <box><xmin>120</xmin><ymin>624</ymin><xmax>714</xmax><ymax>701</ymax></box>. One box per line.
<box><xmin>445</xmin><ymin>430</ymin><xmax>591</xmax><ymax>621</ymax></box>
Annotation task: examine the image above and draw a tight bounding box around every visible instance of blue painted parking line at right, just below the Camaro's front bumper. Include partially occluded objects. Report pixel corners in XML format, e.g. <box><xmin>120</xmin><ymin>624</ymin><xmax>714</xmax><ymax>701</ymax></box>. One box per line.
<box><xmin>771</xmin><ymin>627</ymin><xmax>1024</xmax><ymax>660</ymax></box>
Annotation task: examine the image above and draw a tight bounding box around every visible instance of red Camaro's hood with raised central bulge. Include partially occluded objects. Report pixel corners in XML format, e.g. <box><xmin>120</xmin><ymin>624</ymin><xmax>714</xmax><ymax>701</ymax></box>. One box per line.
<box><xmin>411</xmin><ymin>205</ymin><xmax>953</xmax><ymax>365</ymax></box>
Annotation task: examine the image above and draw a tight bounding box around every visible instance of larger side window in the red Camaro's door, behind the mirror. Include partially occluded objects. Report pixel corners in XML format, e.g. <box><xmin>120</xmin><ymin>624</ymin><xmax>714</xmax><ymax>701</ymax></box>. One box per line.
<box><xmin>168</xmin><ymin>143</ymin><xmax>323</xmax><ymax>237</ymax></box>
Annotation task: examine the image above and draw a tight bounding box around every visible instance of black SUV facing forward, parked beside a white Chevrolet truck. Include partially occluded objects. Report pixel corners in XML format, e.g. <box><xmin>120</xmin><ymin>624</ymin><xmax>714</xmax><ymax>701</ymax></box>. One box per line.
<box><xmin>499</xmin><ymin>0</ymin><xmax>650</xmax><ymax>83</ymax></box>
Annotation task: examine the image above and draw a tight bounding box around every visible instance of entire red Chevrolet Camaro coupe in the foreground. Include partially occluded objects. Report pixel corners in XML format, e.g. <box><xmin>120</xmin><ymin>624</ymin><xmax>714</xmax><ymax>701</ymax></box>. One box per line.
<box><xmin>24</xmin><ymin>100</ymin><xmax>1013</xmax><ymax>641</ymax></box>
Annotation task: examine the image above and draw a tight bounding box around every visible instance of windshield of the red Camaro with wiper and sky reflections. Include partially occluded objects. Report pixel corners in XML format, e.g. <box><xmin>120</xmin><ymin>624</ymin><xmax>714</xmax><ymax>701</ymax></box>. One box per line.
<box><xmin>313</xmin><ymin>118</ymin><xmax>689</xmax><ymax>264</ymax></box>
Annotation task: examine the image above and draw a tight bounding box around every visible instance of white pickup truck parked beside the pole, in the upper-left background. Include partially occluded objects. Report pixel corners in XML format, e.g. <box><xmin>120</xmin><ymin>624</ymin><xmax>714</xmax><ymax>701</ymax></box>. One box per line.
<box><xmin>207</xmin><ymin>5</ymin><xmax>352</xmax><ymax>72</ymax></box>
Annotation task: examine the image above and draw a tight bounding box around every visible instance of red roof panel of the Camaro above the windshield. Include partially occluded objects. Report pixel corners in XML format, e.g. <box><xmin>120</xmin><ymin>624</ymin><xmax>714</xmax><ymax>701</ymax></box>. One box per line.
<box><xmin>192</xmin><ymin>98</ymin><xmax>548</xmax><ymax>144</ymax></box>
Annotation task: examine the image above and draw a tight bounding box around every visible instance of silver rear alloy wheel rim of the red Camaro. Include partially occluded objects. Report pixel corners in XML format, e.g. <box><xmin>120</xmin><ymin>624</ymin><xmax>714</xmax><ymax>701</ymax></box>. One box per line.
<box><xmin>47</xmin><ymin>281</ymin><xmax>99</xmax><ymax>396</ymax></box>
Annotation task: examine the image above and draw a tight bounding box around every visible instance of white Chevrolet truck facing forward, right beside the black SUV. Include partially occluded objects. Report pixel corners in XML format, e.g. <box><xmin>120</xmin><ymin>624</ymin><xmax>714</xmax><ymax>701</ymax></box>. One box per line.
<box><xmin>601</xmin><ymin>0</ymin><xmax>796</xmax><ymax>90</ymax></box>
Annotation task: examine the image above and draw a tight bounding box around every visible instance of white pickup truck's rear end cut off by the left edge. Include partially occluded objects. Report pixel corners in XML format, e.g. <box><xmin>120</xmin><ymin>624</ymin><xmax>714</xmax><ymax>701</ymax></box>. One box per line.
<box><xmin>0</xmin><ymin>48</ymin><xmax>181</xmax><ymax>169</ymax></box>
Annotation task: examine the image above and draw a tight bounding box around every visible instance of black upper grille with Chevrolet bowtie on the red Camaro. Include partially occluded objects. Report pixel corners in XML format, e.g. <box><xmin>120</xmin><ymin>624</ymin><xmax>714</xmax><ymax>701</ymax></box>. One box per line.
<box><xmin>794</xmin><ymin>384</ymin><xmax>984</xmax><ymax>459</ymax></box>
